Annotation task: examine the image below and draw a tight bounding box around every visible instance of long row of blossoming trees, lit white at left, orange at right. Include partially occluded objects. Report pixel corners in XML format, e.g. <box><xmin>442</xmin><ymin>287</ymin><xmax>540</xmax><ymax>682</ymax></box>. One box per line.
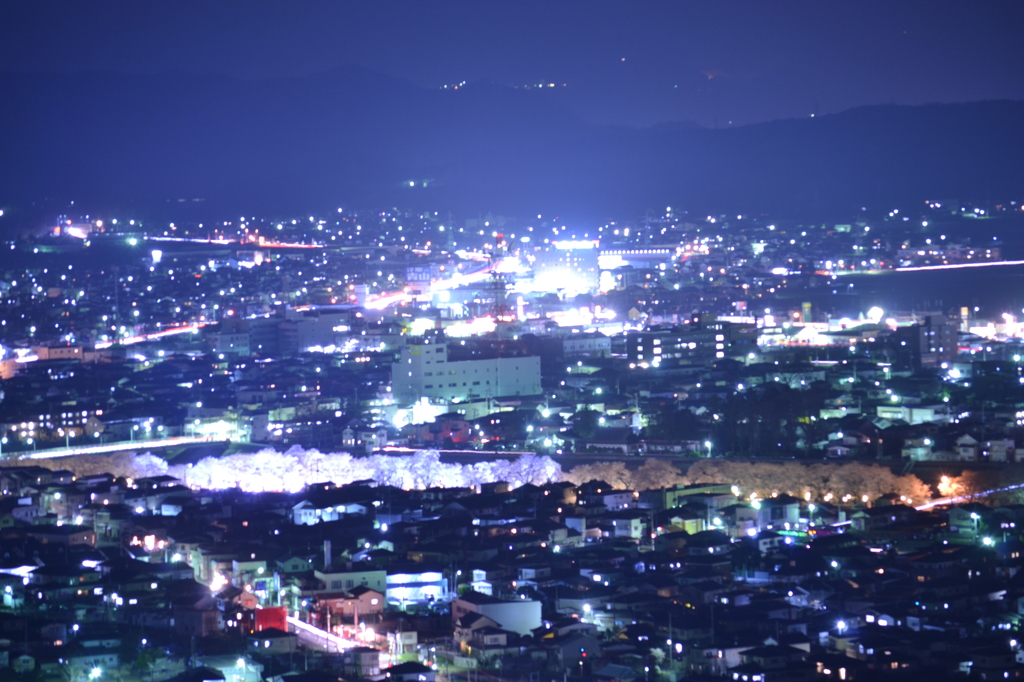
<box><xmin>19</xmin><ymin>446</ymin><xmax>932</xmax><ymax>505</ymax></box>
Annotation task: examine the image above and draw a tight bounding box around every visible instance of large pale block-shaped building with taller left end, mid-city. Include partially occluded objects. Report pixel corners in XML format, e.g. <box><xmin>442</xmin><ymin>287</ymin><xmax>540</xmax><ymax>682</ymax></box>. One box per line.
<box><xmin>391</xmin><ymin>343</ymin><xmax>541</xmax><ymax>403</ymax></box>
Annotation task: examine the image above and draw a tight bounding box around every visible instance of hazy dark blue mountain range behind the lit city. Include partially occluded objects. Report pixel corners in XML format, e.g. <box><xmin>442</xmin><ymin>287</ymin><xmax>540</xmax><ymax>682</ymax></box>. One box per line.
<box><xmin>0</xmin><ymin>67</ymin><xmax>1024</xmax><ymax>218</ymax></box>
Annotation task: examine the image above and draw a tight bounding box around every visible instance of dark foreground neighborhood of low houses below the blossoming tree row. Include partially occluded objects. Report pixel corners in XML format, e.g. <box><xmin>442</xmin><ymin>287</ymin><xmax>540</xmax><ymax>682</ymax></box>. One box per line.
<box><xmin>0</xmin><ymin>450</ymin><xmax>1024</xmax><ymax>681</ymax></box>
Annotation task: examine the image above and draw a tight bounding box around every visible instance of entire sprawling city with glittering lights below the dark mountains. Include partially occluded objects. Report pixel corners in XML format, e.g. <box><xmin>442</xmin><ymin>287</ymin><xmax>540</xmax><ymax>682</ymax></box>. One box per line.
<box><xmin>0</xmin><ymin>196</ymin><xmax>1024</xmax><ymax>678</ymax></box>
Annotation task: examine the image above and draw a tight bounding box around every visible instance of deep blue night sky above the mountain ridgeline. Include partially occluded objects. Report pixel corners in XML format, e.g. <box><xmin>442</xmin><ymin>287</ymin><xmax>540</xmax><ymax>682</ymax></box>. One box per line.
<box><xmin>0</xmin><ymin>0</ymin><xmax>1024</xmax><ymax>127</ymax></box>
